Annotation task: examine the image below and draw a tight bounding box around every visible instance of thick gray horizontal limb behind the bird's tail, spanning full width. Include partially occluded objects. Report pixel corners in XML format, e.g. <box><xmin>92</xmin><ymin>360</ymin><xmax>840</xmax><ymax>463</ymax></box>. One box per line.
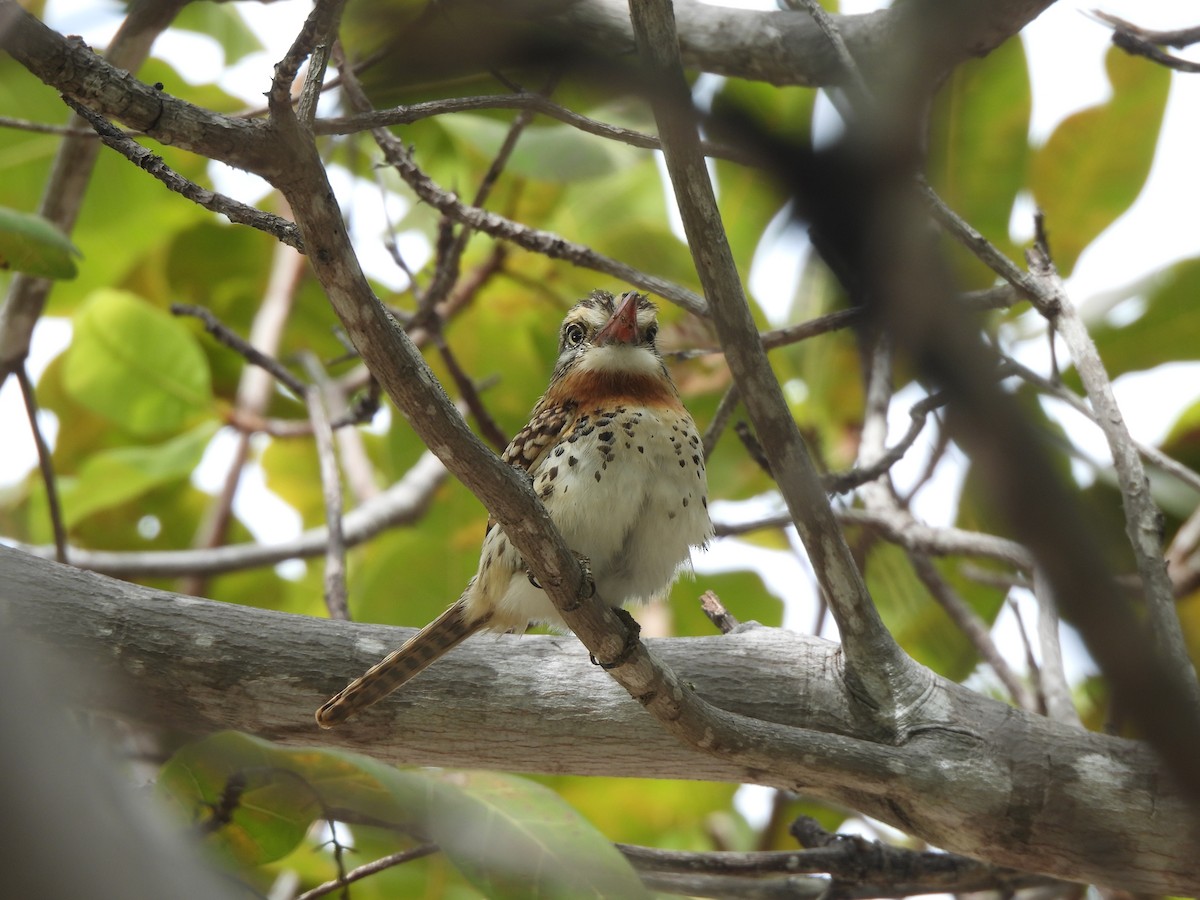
<box><xmin>0</xmin><ymin>548</ymin><xmax>1200</xmax><ymax>895</ymax></box>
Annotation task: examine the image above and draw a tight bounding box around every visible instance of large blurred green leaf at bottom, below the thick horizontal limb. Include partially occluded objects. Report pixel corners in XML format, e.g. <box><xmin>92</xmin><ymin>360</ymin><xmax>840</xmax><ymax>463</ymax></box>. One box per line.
<box><xmin>158</xmin><ymin>732</ymin><xmax>648</xmax><ymax>900</ymax></box>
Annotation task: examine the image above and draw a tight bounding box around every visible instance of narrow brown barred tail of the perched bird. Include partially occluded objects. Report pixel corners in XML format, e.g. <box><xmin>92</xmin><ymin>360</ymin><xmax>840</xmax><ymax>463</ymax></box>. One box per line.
<box><xmin>317</xmin><ymin>600</ymin><xmax>490</xmax><ymax>728</ymax></box>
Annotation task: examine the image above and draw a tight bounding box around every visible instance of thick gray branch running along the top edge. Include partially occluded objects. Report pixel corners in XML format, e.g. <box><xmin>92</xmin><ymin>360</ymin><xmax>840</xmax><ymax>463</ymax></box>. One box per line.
<box><xmin>376</xmin><ymin>0</ymin><xmax>1054</xmax><ymax>86</ymax></box>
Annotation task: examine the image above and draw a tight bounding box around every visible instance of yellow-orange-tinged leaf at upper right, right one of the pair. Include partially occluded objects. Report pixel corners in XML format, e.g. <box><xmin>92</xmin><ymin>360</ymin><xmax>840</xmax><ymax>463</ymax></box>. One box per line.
<box><xmin>1031</xmin><ymin>47</ymin><xmax>1171</xmax><ymax>276</ymax></box>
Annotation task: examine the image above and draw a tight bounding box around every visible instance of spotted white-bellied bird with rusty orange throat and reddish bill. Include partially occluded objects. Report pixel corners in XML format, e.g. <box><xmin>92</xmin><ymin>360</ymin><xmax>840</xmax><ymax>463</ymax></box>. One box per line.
<box><xmin>316</xmin><ymin>290</ymin><xmax>713</xmax><ymax>728</ymax></box>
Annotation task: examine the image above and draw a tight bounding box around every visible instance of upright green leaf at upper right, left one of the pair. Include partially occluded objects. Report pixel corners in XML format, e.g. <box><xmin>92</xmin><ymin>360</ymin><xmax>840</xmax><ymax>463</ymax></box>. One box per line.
<box><xmin>929</xmin><ymin>41</ymin><xmax>1033</xmax><ymax>287</ymax></box>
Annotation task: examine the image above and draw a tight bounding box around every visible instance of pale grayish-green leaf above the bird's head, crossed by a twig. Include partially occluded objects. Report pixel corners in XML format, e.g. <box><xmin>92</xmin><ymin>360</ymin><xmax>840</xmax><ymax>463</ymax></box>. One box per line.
<box><xmin>440</xmin><ymin>113</ymin><xmax>644</xmax><ymax>181</ymax></box>
